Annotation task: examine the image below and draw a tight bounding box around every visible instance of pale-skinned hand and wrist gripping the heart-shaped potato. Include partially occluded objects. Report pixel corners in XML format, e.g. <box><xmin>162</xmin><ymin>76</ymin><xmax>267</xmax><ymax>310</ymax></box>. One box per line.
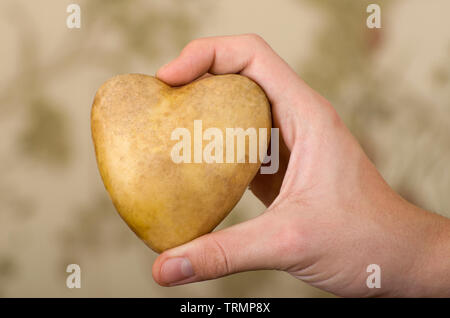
<box><xmin>153</xmin><ymin>34</ymin><xmax>450</xmax><ymax>297</ymax></box>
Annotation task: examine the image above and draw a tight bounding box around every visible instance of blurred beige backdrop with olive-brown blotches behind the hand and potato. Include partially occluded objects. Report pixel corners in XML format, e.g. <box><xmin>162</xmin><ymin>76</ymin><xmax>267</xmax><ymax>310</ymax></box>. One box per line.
<box><xmin>0</xmin><ymin>0</ymin><xmax>450</xmax><ymax>297</ymax></box>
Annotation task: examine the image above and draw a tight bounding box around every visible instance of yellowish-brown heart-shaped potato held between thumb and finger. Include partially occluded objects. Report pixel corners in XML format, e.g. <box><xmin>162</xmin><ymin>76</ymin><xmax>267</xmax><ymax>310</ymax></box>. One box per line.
<box><xmin>91</xmin><ymin>74</ymin><xmax>271</xmax><ymax>252</ymax></box>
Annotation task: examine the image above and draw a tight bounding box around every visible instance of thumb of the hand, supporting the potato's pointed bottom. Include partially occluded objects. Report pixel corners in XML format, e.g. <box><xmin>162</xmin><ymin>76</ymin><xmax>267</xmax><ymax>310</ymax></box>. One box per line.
<box><xmin>153</xmin><ymin>212</ymin><xmax>282</xmax><ymax>286</ymax></box>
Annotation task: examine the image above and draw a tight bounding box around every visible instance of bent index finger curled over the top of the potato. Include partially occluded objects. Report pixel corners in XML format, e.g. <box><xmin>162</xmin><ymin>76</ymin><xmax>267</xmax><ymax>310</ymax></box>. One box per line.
<box><xmin>156</xmin><ymin>34</ymin><xmax>309</xmax><ymax>108</ymax></box>
